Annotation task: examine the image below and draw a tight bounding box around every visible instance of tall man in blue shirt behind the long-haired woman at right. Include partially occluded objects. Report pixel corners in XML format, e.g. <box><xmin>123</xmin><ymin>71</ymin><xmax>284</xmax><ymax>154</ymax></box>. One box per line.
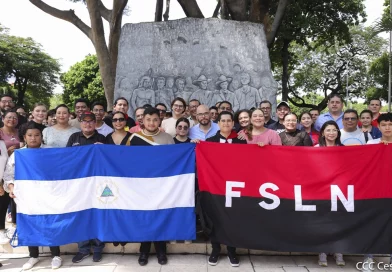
<box><xmin>314</xmin><ymin>94</ymin><xmax>344</xmax><ymax>131</ymax></box>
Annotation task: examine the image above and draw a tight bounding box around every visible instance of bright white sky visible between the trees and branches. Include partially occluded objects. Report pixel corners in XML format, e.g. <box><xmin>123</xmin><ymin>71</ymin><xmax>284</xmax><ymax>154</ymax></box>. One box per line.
<box><xmin>0</xmin><ymin>0</ymin><xmax>384</xmax><ymax>92</ymax></box>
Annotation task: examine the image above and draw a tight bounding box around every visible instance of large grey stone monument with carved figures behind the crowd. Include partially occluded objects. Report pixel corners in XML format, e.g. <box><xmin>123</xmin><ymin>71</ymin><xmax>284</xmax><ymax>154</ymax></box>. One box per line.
<box><xmin>114</xmin><ymin>18</ymin><xmax>278</xmax><ymax>116</ymax></box>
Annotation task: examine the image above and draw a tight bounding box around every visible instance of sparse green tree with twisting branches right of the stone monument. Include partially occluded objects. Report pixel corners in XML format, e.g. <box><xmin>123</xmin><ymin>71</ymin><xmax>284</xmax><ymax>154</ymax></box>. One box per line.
<box><xmin>289</xmin><ymin>27</ymin><xmax>386</xmax><ymax>110</ymax></box>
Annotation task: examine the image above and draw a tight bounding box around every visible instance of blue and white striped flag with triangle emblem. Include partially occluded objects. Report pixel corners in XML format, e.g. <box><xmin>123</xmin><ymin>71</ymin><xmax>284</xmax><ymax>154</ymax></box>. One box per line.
<box><xmin>14</xmin><ymin>144</ymin><xmax>196</xmax><ymax>246</ymax></box>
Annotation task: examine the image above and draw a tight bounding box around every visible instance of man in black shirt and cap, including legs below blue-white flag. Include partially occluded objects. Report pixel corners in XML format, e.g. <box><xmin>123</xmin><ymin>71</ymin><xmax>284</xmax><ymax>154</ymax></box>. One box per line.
<box><xmin>67</xmin><ymin>111</ymin><xmax>106</xmax><ymax>263</ymax></box>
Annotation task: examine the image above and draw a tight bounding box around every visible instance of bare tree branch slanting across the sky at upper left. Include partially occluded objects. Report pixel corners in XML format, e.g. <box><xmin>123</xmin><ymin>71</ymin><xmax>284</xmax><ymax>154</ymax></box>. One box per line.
<box><xmin>29</xmin><ymin>0</ymin><xmax>93</xmax><ymax>40</ymax></box>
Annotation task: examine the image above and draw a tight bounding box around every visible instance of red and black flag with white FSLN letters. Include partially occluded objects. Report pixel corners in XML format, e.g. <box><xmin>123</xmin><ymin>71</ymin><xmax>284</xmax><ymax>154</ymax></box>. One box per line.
<box><xmin>196</xmin><ymin>143</ymin><xmax>392</xmax><ymax>253</ymax></box>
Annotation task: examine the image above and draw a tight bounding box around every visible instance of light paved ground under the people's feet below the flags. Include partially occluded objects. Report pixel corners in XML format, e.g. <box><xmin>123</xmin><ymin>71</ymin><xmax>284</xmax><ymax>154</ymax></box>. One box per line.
<box><xmin>0</xmin><ymin>254</ymin><xmax>389</xmax><ymax>272</ymax></box>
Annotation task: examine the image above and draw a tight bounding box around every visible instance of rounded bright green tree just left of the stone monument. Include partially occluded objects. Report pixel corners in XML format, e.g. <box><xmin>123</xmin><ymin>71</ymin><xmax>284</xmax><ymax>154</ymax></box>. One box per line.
<box><xmin>60</xmin><ymin>55</ymin><xmax>106</xmax><ymax>109</ymax></box>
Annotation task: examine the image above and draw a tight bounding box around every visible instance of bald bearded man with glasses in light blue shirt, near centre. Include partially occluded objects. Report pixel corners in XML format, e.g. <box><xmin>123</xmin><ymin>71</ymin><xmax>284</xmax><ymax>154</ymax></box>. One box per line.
<box><xmin>189</xmin><ymin>105</ymin><xmax>219</xmax><ymax>141</ymax></box>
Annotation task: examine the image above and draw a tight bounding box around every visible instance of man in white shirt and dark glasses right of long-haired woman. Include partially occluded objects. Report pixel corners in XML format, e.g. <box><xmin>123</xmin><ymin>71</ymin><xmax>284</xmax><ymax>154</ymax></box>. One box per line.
<box><xmin>340</xmin><ymin>109</ymin><xmax>373</xmax><ymax>145</ymax></box>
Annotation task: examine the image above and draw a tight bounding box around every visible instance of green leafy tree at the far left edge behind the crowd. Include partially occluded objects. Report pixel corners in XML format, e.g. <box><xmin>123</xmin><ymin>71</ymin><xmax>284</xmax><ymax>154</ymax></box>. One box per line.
<box><xmin>0</xmin><ymin>27</ymin><xmax>60</xmax><ymax>106</ymax></box>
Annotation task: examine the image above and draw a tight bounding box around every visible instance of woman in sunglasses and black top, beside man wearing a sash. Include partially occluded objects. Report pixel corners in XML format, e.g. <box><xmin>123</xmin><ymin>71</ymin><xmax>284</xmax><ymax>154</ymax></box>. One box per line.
<box><xmin>106</xmin><ymin>111</ymin><xmax>131</xmax><ymax>145</ymax></box>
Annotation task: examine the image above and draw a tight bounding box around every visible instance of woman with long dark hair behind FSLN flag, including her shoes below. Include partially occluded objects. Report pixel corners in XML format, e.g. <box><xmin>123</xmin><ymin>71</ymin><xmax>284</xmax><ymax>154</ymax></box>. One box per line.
<box><xmin>315</xmin><ymin>120</ymin><xmax>346</xmax><ymax>267</ymax></box>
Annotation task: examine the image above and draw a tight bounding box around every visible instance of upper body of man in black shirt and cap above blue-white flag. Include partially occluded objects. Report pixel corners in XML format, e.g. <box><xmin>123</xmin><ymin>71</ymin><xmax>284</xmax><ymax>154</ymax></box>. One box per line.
<box><xmin>67</xmin><ymin>111</ymin><xmax>106</xmax><ymax>147</ymax></box>
